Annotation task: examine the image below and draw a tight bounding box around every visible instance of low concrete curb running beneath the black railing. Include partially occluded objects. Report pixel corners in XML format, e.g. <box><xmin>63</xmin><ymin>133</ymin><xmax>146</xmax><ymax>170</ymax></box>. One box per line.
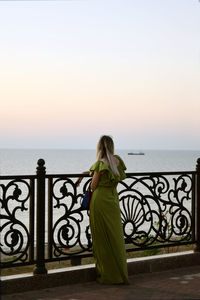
<box><xmin>1</xmin><ymin>251</ymin><xmax>200</xmax><ymax>295</ymax></box>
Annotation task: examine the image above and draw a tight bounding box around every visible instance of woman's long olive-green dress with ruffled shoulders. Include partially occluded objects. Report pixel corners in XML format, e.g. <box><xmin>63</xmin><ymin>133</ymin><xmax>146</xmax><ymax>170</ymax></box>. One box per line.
<box><xmin>90</xmin><ymin>156</ymin><xmax>129</xmax><ymax>284</ymax></box>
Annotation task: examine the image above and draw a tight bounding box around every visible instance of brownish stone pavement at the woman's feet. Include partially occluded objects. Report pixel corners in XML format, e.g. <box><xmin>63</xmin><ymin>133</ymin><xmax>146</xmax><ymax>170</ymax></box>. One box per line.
<box><xmin>2</xmin><ymin>266</ymin><xmax>200</xmax><ymax>300</ymax></box>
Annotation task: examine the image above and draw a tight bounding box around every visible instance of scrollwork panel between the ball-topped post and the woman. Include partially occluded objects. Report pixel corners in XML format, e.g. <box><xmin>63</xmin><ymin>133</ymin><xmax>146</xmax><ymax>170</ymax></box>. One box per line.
<box><xmin>50</xmin><ymin>178</ymin><xmax>92</xmax><ymax>257</ymax></box>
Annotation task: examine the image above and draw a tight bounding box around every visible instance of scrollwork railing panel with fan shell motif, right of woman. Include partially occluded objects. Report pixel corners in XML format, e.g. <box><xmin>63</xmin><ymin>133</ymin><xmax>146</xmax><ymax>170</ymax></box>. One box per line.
<box><xmin>118</xmin><ymin>174</ymin><xmax>193</xmax><ymax>247</ymax></box>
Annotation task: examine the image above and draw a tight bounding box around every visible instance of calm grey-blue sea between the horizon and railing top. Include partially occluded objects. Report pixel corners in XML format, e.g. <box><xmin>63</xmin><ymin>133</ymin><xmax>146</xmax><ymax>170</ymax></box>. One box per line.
<box><xmin>0</xmin><ymin>149</ymin><xmax>200</xmax><ymax>175</ymax></box>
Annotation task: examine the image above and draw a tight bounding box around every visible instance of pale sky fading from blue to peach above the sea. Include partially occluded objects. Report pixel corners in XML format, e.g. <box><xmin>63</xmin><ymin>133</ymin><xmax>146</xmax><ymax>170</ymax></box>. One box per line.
<box><xmin>0</xmin><ymin>0</ymin><xmax>200</xmax><ymax>150</ymax></box>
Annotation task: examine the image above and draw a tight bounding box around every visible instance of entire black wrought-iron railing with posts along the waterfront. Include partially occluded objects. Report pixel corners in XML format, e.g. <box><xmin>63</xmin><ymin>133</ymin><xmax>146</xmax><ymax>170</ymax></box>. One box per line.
<box><xmin>0</xmin><ymin>159</ymin><xmax>200</xmax><ymax>274</ymax></box>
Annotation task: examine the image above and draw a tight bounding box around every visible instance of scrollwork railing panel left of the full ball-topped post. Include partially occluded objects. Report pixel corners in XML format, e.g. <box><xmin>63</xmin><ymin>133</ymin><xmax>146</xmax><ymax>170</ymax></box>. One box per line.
<box><xmin>0</xmin><ymin>179</ymin><xmax>32</xmax><ymax>265</ymax></box>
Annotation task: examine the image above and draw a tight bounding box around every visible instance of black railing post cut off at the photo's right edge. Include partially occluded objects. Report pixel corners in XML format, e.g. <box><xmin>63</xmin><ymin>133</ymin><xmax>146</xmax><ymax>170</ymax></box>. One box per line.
<box><xmin>195</xmin><ymin>158</ymin><xmax>200</xmax><ymax>252</ymax></box>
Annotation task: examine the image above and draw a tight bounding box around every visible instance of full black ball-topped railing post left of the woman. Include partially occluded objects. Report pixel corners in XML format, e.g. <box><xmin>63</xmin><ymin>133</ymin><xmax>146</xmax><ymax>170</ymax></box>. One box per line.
<box><xmin>33</xmin><ymin>159</ymin><xmax>47</xmax><ymax>275</ymax></box>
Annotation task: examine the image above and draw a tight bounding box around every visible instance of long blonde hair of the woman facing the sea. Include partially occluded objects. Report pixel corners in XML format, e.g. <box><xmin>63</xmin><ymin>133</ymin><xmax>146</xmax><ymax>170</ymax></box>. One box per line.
<box><xmin>96</xmin><ymin>135</ymin><xmax>119</xmax><ymax>176</ymax></box>
